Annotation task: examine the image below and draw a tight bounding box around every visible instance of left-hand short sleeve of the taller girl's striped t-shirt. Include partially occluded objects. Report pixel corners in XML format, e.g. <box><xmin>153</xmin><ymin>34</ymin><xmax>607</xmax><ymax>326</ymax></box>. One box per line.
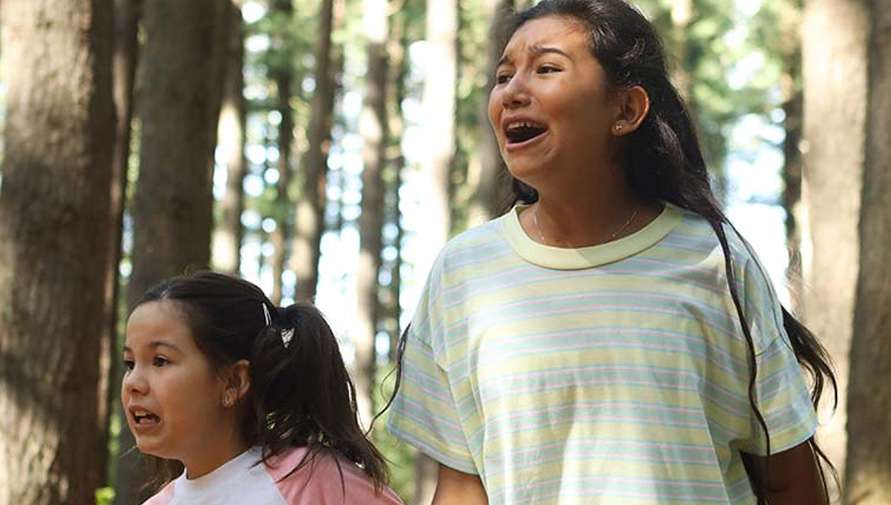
<box><xmin>388</xmin><ymin>262</ymin><xmax>479</xmax><ymax>474</ymax></box>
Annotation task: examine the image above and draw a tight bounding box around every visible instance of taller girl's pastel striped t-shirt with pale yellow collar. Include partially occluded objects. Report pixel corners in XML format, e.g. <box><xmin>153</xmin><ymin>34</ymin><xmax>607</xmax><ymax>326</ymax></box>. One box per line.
<box><xmin>389</xmin><ymin>205</ymin><xmax>816</xmax><ymax>505</ymax></box>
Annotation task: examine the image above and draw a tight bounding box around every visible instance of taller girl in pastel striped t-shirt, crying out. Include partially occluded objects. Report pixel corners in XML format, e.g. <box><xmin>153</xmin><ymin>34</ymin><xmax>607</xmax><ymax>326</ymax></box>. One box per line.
<box><xmin>390</xmin><ymin>0</ymin><xmax>834</xmax><ymax>505</ymax></box>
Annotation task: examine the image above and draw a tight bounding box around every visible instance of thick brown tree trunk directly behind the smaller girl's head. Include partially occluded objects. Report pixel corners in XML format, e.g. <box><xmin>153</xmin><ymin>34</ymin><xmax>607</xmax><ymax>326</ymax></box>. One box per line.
<box><xmin>116</xmin><ymin>0</ymin><xmax>229</xmax><ymax>504</ymax></box>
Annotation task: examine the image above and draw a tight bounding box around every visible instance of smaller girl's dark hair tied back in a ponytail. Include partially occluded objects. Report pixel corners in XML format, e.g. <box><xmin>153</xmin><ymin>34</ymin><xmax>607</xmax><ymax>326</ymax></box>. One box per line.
<box><xmin>131</xmin><ymin>271</ymin><xmax>387</xmax><ymax>490</ymax></box>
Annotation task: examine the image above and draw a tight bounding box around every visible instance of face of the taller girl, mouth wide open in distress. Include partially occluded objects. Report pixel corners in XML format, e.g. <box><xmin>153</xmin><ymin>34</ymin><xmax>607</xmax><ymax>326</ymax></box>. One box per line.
<box><xmin>489</xmin><ymin>16</ymin><xmax>619</xmax><ymax>189</ymax></box>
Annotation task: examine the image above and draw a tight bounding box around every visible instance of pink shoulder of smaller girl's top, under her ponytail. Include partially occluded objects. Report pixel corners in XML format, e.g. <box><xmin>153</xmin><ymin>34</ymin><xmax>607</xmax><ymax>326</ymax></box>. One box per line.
<box><xmin>267</xmin><ymin>447</ymin><xmax>402</xmax><ymax>505</ymax></box>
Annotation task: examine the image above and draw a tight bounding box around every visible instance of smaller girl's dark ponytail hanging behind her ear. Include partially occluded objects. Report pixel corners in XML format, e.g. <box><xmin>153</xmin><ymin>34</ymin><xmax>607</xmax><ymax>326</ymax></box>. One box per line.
<box><xmin>248</xmin><ymin>303</ymin><xmax>387</xmax><ymax>487</ymax></box>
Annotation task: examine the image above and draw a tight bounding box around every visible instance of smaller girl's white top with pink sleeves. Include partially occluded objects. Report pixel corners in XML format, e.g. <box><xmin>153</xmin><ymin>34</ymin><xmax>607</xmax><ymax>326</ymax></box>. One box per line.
<box><xmin>145</xmin><ymin>447</ymin><xmax>402</xmax><ymax>505</ymax></box>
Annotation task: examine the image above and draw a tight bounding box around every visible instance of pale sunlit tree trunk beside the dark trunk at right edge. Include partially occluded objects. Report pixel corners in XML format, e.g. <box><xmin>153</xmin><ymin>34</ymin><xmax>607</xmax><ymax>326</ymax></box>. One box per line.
<box><xmin>802</xmin><ymin>0</ymin><xmax>869</xmax><ymax>480</ymax></box>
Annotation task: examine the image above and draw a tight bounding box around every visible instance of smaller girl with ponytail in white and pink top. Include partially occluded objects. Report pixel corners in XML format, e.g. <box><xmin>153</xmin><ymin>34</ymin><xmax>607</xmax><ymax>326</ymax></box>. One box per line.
<box><xmin>121</xmin><ymin>272</ymin><xmax>401</xmax><ymax>505</ymax></box>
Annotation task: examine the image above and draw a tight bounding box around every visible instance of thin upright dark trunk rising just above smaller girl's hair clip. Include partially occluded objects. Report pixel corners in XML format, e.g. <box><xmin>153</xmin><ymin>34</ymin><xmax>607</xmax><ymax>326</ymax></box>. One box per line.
<box><xmin>270</xmin><ymin>0</ymin><xmax>294</xmax><ymax>305</ymax></box>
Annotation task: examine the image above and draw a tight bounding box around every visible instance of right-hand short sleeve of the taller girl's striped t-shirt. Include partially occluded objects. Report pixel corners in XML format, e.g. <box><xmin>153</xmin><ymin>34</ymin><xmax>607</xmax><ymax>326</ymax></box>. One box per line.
<box><xmin>740</xmin><ymin>257</ymin><xmax>817</xmax><ymax>455</ymax></box>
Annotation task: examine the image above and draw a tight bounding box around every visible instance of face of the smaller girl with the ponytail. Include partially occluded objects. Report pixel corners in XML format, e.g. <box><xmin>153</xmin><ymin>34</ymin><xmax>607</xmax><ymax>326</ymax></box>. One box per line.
<box><xmin>121</xmin><ymin>301</ymin><xmax>235</xmax><ymax>468</ymax></box>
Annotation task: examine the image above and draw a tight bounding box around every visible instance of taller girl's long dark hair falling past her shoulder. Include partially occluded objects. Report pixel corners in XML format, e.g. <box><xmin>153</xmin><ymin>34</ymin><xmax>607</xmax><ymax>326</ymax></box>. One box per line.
<box><xmin>502</xmin><ymin>0</ymin><xmax>837</xmax><ymax>498</ymax></box>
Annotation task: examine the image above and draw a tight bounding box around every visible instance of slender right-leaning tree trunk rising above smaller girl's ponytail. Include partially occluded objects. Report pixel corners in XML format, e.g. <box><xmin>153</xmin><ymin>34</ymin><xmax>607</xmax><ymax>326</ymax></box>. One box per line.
<box><xmin>291</xmin><ymin>0</ymin><xmax>345</xmax><ymax>301</ymax></box>
